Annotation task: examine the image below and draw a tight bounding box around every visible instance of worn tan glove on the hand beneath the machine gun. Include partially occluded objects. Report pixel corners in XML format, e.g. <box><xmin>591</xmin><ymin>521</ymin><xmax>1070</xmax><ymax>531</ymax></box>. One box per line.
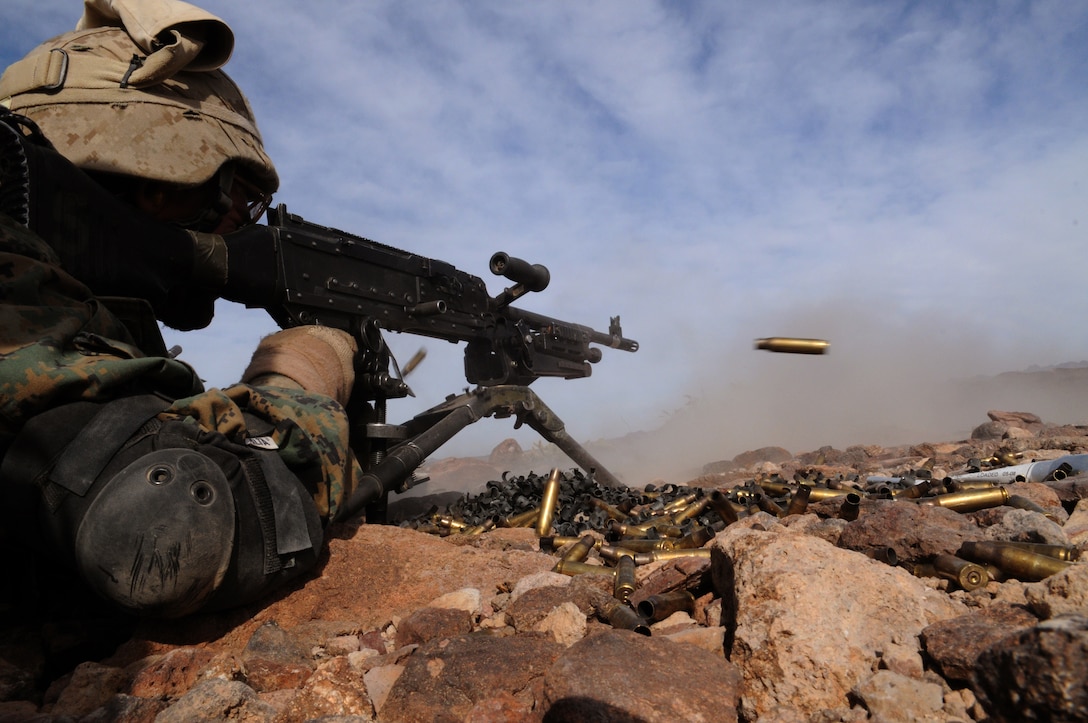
<box><xmin>242</xmin><ymin>326</ymin><xmax>358</xmax><ymax>406</ymax></box>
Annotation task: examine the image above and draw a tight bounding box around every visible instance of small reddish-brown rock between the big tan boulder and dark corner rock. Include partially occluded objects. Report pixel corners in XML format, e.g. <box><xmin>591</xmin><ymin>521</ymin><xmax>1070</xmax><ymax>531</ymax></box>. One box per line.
<box><xmin>920</xmin><ymin>603</ymin><xmax>1039</xmax><ymax>682</ymax></box>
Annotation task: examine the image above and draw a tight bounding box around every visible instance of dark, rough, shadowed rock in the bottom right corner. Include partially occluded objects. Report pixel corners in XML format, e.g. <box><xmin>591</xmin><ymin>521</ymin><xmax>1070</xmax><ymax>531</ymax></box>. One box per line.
<box><xmin>972</xmin><ymin>615</ymin><xmax>1088</xmax><ymax>723</ymax></box>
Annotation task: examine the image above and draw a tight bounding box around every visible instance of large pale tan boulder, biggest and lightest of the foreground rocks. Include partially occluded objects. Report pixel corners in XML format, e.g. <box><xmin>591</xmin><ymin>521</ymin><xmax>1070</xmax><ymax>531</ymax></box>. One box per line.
<box><xmin>712</xmin><ymin>521</ymin><xmax>965</xmax><ymax>720</ymax></box>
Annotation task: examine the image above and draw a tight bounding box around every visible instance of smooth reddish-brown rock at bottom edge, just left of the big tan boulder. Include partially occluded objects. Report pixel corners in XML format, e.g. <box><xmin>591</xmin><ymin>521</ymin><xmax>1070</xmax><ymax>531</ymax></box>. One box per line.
<box><xmin>544</xmin><ymin>629</ymin><xmax>741</xmax><ymax>723</ymax></box>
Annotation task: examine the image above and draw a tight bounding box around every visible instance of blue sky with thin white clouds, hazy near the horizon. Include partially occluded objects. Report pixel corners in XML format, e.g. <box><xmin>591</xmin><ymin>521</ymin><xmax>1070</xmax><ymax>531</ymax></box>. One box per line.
<box><xmin>0</xmin><ymin>0</ymin><xmax>1088</xmax><ymax>471</ymax></box>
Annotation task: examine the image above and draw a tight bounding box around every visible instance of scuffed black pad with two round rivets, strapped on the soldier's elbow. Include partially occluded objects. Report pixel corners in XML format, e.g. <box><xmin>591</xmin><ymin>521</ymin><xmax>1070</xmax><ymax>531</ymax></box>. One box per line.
<box><xmin>0</xmin><ymin>397</ymin><xmax>322</xmax><ymax>618</ymax></box>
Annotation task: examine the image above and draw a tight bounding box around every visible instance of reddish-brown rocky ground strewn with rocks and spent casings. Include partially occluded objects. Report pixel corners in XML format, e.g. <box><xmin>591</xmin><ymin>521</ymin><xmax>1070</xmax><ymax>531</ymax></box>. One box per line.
<box><xmin>0</xmin><ymin>412</ymin><xmax>1088</xmax><ymax>723</ymax></box>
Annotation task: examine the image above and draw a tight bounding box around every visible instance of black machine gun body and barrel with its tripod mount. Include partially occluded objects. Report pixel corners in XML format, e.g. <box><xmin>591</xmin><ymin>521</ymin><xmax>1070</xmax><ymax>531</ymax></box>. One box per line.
<box><xmin>265</xmin><ymin>205</ymin><xmax>639</xmax><ymax>519</ymax></box>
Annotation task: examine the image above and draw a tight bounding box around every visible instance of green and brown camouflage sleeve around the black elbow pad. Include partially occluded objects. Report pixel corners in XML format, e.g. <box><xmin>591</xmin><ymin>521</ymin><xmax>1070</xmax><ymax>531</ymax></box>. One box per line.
<box><xmin>0</xmin><ymin>215</ymin><xmax>361</xmax><ymax>519</ymax></box>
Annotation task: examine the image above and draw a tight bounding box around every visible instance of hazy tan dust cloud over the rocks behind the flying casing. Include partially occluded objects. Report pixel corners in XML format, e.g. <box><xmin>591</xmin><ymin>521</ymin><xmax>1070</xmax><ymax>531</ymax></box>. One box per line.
<box><xmin>590</xmin><ymin>301</ymin><xmax>1088</xmax><ymax>485</ymax></box>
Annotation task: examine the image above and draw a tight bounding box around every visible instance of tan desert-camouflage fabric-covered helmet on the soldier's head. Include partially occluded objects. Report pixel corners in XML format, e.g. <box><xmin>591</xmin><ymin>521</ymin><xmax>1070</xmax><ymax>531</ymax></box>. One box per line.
<box><xmin>0</xmin><ymin>27</ymin><xmax>280</xmax><ymax>194</ymax></box>
